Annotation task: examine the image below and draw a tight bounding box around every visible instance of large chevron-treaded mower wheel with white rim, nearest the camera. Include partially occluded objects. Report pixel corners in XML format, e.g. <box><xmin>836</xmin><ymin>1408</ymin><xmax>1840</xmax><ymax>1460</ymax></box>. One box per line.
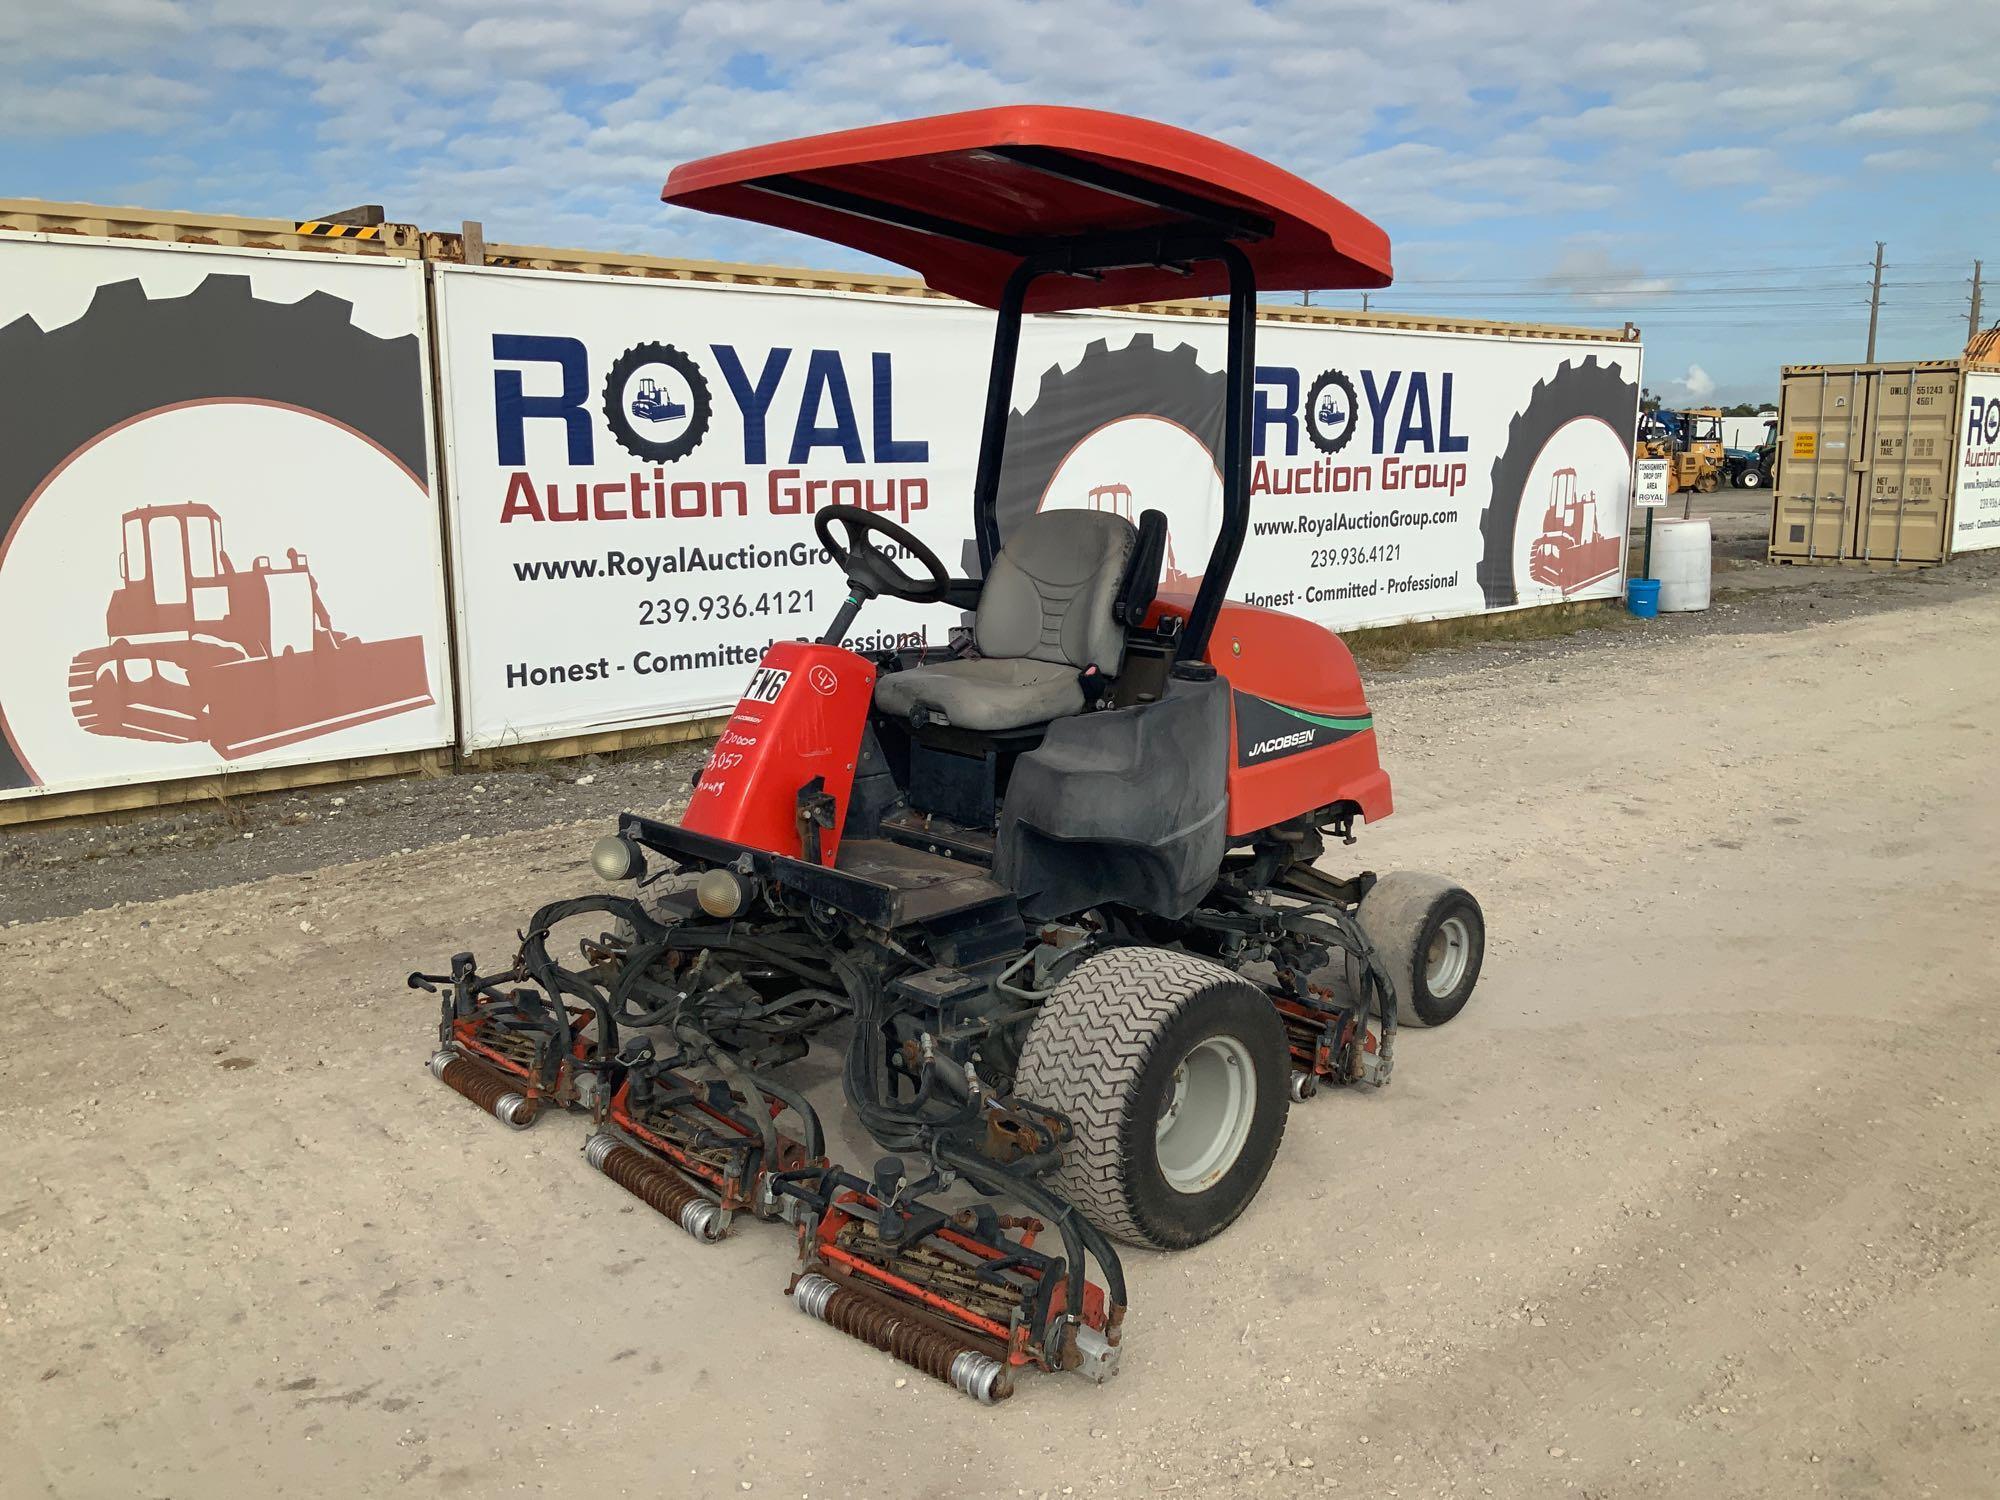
<box><xmin>1014</xmin><ymin>948</ymin><xmax>1292</xmax><ymax>1250</ymax></box>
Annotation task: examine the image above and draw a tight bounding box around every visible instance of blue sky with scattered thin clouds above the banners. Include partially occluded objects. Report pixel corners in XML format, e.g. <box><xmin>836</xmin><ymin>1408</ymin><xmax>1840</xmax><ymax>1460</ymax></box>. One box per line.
<box><xmin>0</xmin><ymin>0</ymin><xmax>2000</xmax><ymax>400</ymax></box>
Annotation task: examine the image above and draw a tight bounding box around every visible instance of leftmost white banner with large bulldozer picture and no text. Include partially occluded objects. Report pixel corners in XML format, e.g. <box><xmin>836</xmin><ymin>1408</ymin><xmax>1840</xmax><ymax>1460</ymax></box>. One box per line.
<box><xmin>0</xmin><ymin>234</ymin><xmax>452</xmax><ymax>796</ymax></box>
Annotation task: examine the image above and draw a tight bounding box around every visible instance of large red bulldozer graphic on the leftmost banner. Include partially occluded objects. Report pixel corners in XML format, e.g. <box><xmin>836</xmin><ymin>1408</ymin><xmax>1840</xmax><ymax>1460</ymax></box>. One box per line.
<box><xmin>70</xmin><ymin>504</ymin><xmax>432</xmax><ymax>760</ymax></box>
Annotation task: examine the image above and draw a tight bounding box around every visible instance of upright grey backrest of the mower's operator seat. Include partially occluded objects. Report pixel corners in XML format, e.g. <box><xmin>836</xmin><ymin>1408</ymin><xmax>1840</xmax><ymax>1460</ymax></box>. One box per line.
<box><xmin>972</xmin><ymin>510</ymin><xmax>1138</xmax><ymax>676</ymax></box>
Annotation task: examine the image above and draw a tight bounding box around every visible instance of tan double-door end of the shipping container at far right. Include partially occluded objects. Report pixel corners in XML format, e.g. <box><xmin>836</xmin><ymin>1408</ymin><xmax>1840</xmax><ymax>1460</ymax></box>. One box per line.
<box><xmin>1770</xmin><ymin>360</ymin><xmax>1964</xmax><ymax>568</ymax></box>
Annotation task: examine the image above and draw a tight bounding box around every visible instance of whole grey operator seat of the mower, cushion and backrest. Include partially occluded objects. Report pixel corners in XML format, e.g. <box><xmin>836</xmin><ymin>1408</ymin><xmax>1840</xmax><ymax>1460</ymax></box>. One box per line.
<box><xmin>876</xmin><ymin>510</ymin><xmax>1166</xmax><ymax>734</ymax></box>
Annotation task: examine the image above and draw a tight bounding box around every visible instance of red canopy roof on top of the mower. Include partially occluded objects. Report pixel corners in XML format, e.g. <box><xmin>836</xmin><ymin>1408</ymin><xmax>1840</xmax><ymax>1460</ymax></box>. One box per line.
<box><xmin>660</xmin><ymin>104</ymin><xmax>1390</xmax><ymax>312</ymax></box>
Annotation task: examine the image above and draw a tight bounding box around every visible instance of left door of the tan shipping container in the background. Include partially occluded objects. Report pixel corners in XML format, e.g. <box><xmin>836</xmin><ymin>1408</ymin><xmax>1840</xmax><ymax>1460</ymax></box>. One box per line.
<box><xmin>1770</xmin><ymin>370</ymin><xmax>1868</xmax><ymax>562</ymax></box>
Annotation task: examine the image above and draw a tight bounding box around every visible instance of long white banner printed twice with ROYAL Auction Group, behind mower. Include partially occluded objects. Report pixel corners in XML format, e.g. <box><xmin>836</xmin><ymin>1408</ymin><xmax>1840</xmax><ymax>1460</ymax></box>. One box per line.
<box><xmin>436</xmin><ymin>266</ymin><xmax>1640</xmax><ymax>746</ymax></box>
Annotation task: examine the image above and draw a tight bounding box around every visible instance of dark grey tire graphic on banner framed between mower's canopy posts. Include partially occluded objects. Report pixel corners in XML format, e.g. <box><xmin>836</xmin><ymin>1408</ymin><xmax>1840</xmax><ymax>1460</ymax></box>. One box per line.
<box><xmin>998</xmin><ymin>332</ymin><xmax>1226</xmax><ymax>566</ymax></box>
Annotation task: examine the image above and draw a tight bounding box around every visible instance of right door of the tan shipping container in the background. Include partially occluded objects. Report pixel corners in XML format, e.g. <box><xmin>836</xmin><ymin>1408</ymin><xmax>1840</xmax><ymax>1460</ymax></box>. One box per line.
<box><xmin>1854</xmin><ymin>368</ymin><xmax>1958</xmax><ymax>566</ymax></box>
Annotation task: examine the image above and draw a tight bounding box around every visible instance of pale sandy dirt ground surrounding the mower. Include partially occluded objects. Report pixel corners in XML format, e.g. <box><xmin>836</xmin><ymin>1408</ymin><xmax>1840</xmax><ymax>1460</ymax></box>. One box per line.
<box><xmin>0</xmin><ymin>568</ymin><xmax>2000</xmax><ymax>1500</ymax></box>
